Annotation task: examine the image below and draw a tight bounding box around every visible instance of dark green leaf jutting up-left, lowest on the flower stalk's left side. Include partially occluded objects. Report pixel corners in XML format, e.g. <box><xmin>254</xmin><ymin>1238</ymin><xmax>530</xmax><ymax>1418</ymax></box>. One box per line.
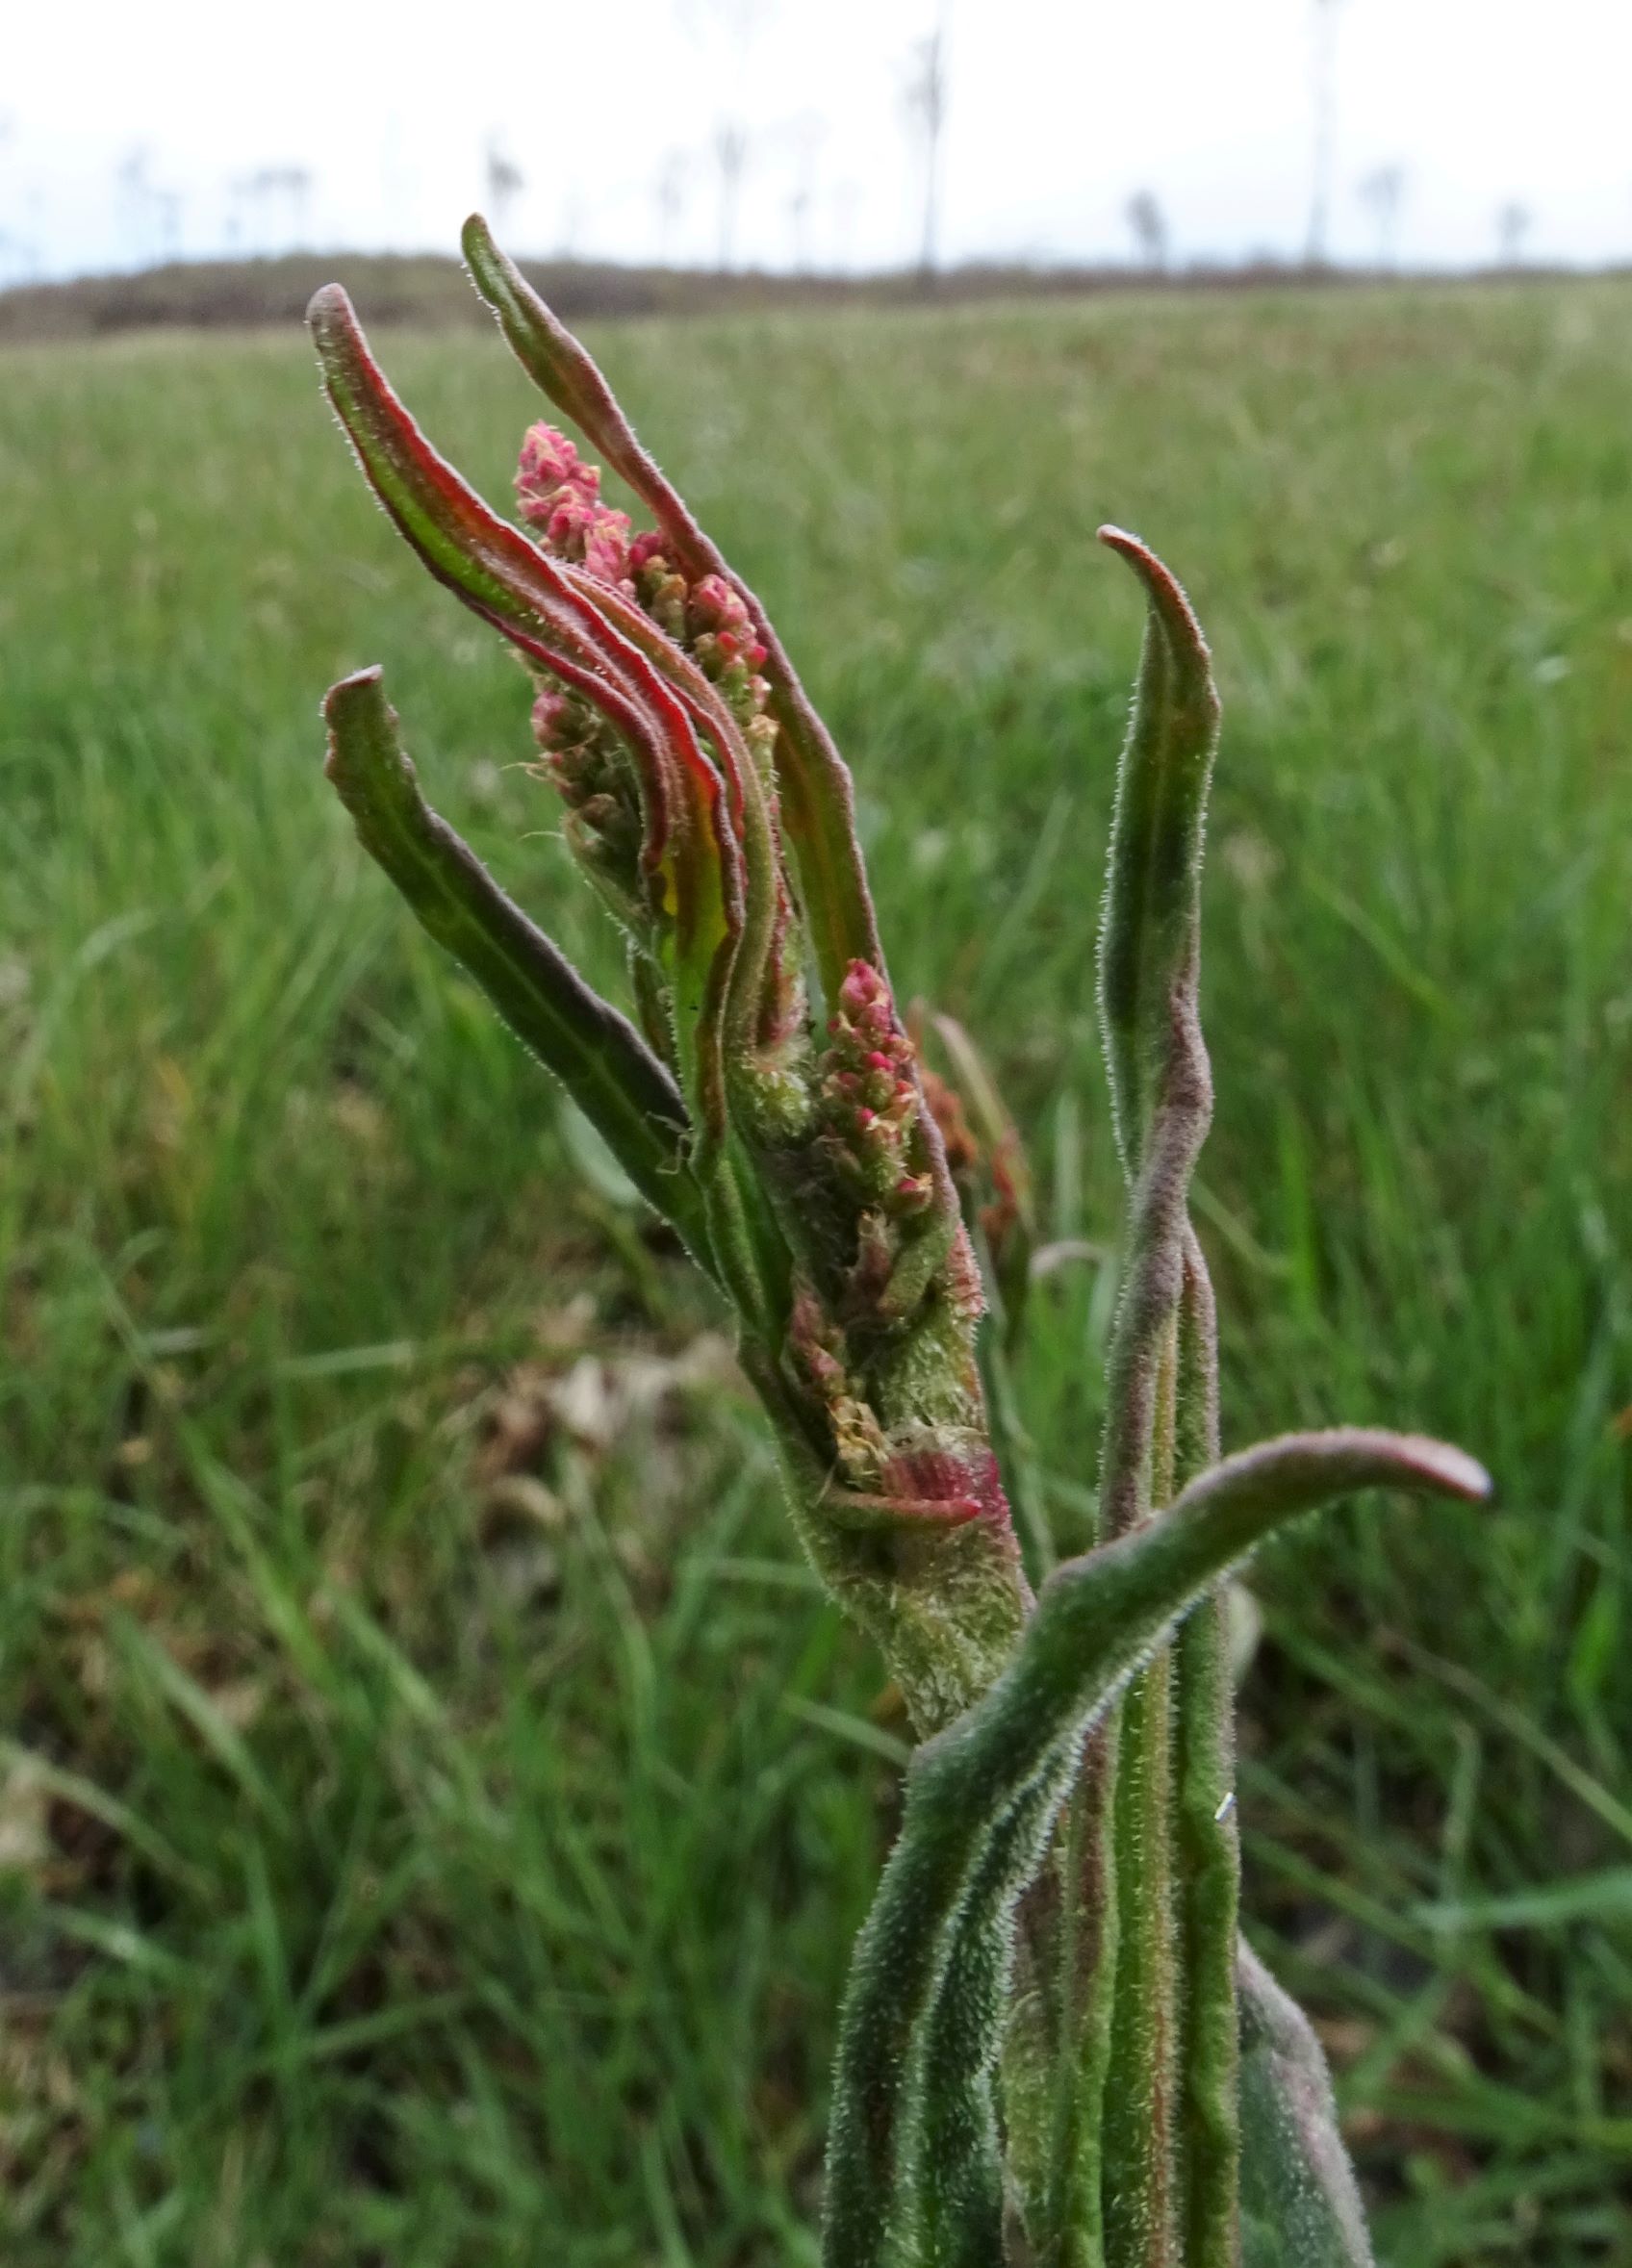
<box><xmin>324</xmin><ymin>669</ymin><xmax>714</xmax><ymax>1272</ymax></box>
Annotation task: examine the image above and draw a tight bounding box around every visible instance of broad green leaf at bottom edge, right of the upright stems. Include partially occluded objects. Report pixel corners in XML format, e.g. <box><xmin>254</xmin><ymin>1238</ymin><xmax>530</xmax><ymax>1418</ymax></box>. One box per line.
<box><xmin>1236</xmin><ymin>1942</ymin><xmax>1373</xmax><ymax>2268</ymax></box>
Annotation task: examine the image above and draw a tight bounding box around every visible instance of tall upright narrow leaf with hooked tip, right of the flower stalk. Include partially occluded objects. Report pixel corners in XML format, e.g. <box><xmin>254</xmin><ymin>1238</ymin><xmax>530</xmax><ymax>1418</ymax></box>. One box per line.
<box><xmin>1087</xmin><ymin>528</ymin><xmax>1217</xmax><ymax>2268</ymax></box>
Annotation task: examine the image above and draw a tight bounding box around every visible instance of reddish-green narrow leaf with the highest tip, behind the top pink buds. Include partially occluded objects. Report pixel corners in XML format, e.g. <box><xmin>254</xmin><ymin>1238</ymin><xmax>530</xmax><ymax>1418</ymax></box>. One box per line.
<box><xmin>463</xmin><ymin>214</ymin><xmax>884</xmax><ymax>1003</ymax></box>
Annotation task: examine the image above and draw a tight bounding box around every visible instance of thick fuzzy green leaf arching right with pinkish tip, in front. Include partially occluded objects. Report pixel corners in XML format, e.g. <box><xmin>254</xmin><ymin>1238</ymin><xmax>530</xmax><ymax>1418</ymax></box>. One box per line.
<box><xmin>823</xmin><ymin>1429</ymin><xmax>1490</xmax><ymax>2268</ymax></box>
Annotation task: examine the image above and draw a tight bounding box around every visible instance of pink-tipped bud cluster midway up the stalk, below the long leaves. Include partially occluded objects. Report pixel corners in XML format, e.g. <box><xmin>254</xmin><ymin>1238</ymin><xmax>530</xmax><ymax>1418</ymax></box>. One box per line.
<box><xmin>818</xmin><ymin>961</ymin><xmax>933</xmax><ymax>1220</ymax></box>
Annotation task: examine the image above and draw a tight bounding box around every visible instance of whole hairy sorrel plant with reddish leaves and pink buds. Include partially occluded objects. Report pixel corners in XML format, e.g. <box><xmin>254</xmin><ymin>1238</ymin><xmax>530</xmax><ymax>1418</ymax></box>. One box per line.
<box><xmin>311</xmin><ymin>220</ymin><xmax>1490</xmax><ymax>2268</ymax></box>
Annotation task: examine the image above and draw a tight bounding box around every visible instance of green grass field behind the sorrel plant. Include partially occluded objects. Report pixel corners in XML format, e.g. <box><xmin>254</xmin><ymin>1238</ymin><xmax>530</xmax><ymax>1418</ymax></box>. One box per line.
<box><xmin>0</xmin><ymin>286</ymin><xmax>1632</xmax><ymax>2268</ymax></box>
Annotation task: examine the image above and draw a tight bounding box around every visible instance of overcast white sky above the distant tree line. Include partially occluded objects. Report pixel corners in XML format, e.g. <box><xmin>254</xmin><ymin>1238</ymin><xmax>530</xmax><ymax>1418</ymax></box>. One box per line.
<box><xmin>0</xmin><ymin>0</ymin><xmax>1632</xmax><ymax>281</ymax></box>
